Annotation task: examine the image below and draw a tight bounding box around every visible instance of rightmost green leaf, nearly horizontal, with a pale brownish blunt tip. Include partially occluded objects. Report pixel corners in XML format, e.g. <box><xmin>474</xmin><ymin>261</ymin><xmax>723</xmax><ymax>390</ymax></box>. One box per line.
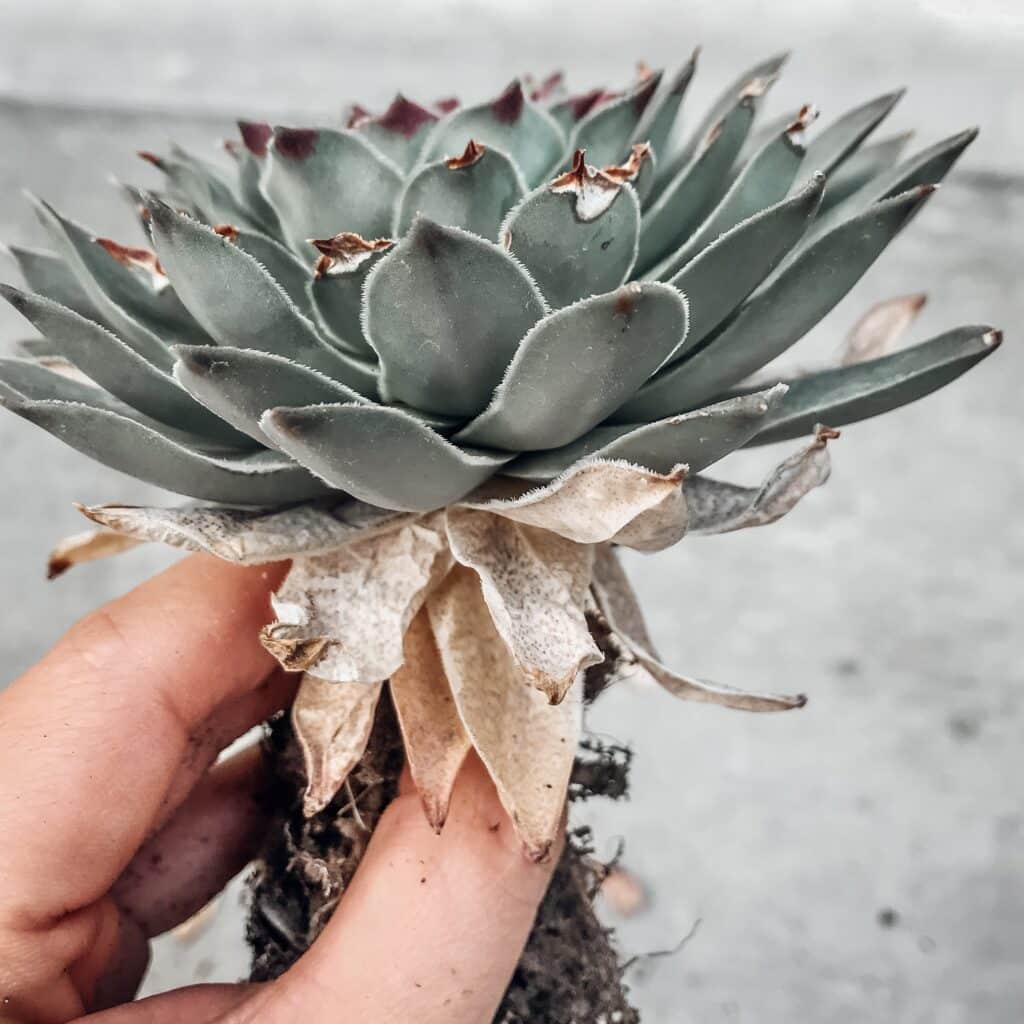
<box><xmin>753</xmin><ymin>326</ymin><xmax>1002</xmax><ymax>444</ymax></box>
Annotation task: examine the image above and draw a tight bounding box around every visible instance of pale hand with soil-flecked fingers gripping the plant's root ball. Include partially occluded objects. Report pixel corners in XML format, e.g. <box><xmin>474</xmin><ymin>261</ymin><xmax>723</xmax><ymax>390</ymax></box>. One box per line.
<box><xmin>0</xmin><ymin>555</ymin><xmax>561</xmax><ymax>1024</ymax></box>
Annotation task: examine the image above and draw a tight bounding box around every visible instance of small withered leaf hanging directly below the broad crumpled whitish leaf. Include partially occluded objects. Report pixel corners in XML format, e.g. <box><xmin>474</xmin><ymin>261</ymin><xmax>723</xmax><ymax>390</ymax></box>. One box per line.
<box><xmin>292</xmin><ymin>673</ymin><xmax>383</xmax><ymax>818</ymax></box>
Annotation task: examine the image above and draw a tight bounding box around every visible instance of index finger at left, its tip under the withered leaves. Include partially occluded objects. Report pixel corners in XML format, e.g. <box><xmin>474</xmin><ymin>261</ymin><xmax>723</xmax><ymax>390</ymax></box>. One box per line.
<box><xmin>0</xmin><ymin>555</ymin><xmax>285</xmax><ymax>926</ymax></box>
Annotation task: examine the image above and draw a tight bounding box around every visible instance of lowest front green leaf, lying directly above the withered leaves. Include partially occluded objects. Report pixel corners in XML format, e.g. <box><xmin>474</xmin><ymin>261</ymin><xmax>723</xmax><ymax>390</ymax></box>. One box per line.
<box><xmin>260</xmin><ymin>404</ymin><xmax>511</xmax><ymax>512</ymax></box>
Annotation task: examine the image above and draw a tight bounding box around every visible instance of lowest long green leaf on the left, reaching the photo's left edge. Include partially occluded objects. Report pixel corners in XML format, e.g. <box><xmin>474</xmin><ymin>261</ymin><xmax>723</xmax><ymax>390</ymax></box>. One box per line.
<box><xmin>0</xmin><ymin>401</ymin><xmax>328</xmax><ymax>505</ymax></box>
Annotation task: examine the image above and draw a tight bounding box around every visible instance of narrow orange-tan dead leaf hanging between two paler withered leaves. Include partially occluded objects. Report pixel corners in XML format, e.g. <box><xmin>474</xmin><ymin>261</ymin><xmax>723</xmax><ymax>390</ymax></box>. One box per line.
<box><xmin>390</xmin><ymin>609</ymin><xmax>470</xmax><ymax>831</ymax></box>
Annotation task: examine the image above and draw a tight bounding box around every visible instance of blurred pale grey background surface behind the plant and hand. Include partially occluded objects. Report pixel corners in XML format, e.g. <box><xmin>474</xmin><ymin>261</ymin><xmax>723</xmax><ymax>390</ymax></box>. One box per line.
<box><xmin>0</xmin><ymin>0</ymin><xmax>1024</xmax><ymax>1024</ymax></box>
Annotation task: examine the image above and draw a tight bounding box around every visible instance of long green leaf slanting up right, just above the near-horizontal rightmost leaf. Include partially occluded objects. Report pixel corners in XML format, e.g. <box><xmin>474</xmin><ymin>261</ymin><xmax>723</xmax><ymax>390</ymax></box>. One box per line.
<box><xmin>620</xmin><ymin>188</ymin><xmax>933</xmax><ymax>421</ymax></box>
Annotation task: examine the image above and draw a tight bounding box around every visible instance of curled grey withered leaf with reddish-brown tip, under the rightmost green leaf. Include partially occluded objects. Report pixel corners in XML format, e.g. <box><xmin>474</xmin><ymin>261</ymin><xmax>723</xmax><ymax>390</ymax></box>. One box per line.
<box><xmin>686</xmin><ymin>427</ymin><xmax>839</xmax><ymax>535</ymax></box>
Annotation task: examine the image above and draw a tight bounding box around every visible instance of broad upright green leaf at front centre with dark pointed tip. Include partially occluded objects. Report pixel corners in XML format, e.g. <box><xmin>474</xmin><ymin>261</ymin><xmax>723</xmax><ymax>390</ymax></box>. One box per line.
<box><xmin>364</xmin><ymin>217</ymin><xmax>547</xmax><ymax>417</ymax></box>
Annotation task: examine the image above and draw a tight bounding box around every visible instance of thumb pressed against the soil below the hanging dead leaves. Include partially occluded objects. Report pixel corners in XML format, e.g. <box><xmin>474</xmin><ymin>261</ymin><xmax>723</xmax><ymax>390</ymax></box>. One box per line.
<box><xmin>259</xmin><ymin>756</ymin><xmax>564</xmax><ymax>1024</ymax></box>
